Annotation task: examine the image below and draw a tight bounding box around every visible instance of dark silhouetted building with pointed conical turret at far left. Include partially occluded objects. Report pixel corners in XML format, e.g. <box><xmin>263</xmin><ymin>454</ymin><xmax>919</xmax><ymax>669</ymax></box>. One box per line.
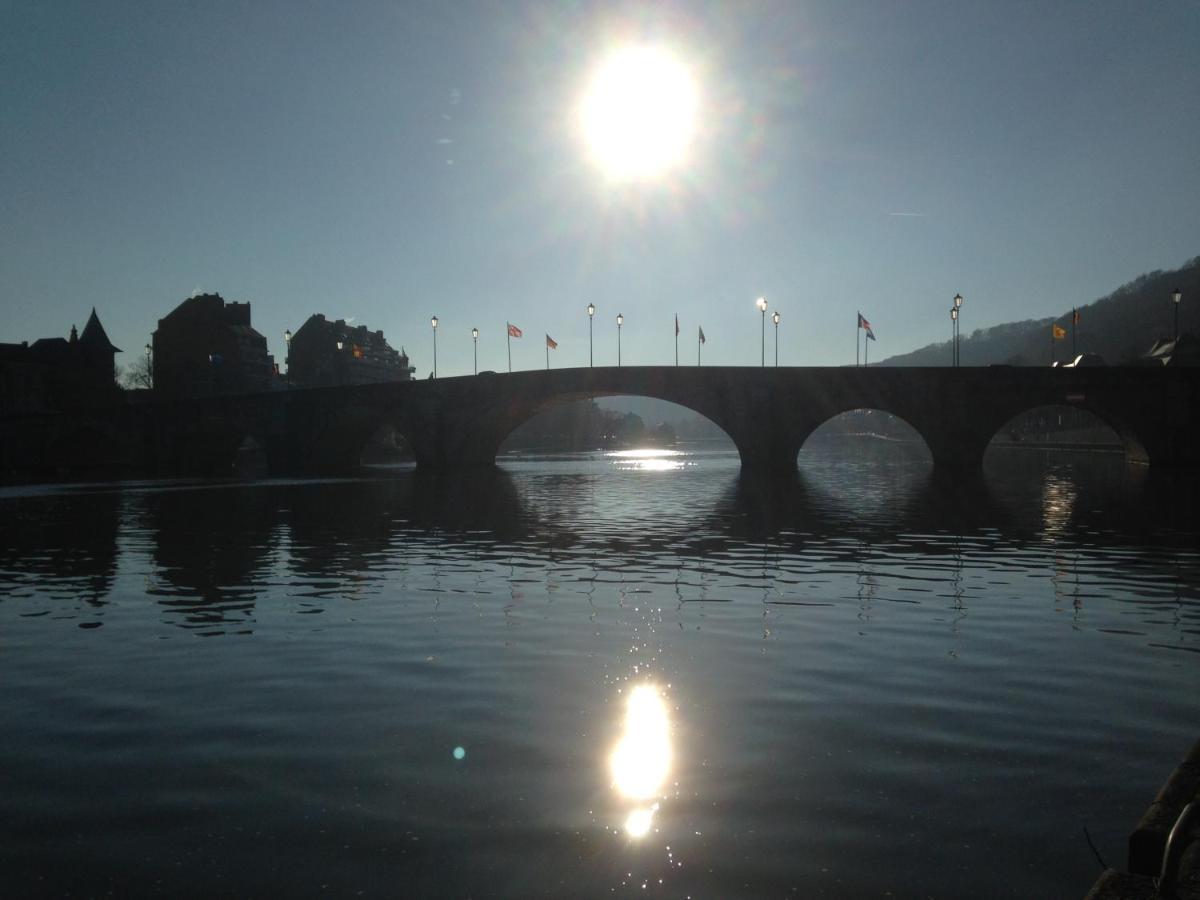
<box><xmin>0</xmin><ymin>307</ymin><xmax>121</xmax><ymax>413</ymax></box>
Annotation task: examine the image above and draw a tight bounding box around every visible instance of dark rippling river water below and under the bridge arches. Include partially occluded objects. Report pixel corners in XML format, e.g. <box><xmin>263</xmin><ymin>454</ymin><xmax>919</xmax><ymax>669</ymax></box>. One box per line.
<box><xmin>0</xmin><ymin>442</ymin><xmax>1200</xmax><ymax>898</ymax></box>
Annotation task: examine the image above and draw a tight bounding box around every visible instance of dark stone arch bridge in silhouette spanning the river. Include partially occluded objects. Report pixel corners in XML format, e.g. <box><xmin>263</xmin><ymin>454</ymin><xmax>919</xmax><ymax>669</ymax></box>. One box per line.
<box><xmin>131</xmin><ymin>366</ymin><xmax>1200</xmax><ymax>473</ymax></box>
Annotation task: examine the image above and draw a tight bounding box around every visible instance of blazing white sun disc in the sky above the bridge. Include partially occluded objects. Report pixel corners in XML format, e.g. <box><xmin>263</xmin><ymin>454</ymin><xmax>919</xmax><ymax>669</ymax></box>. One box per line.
<box><xmin>580</xmin><ymin>47</ymin><xmax>700</xmax><ymax>181</ymax></box>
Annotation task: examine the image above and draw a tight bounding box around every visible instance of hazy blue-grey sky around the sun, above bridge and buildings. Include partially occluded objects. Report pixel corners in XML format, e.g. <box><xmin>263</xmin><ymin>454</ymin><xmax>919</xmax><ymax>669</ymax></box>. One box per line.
<box><xmin>0</xmin><ymin>0</ymin><xmax>1200</xmax><ymax>377</ymax></box>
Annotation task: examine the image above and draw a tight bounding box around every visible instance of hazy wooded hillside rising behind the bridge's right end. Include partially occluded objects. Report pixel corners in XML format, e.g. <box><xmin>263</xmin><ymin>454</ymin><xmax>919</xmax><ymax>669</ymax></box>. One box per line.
<box><xmin>871</xmin><ymin>257</ymin><xmax>1200</xmax><ymax>366</ymax></box>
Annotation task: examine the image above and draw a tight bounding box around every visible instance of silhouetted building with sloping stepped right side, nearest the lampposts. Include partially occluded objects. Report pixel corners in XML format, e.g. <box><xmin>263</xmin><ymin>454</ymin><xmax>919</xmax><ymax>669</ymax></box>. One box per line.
<box><xmin>287</xmin><ymin>313</ymin><xmax>413</xmax><ymax>388</ymax></box>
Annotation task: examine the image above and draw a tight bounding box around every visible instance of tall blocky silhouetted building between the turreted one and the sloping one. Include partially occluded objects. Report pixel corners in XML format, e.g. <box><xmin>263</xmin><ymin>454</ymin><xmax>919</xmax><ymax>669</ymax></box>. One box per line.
<box><xmin>152</xmin><ymin>294</ymin><xmax>275</xmax><ymax>397</ymax></box>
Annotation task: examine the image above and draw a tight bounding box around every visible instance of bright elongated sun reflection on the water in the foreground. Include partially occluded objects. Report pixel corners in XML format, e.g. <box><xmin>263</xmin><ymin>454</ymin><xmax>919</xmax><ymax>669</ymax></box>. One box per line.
<box><xmin>608</xmin><ymin>684</ymin><xmax>671</xmax><ymax>838</ymax></box>
